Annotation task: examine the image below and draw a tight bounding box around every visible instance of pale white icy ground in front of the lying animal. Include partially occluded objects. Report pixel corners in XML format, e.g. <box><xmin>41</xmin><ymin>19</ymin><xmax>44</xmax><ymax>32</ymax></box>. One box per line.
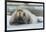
<box><xmin>7</xmin><ymin>16</ymin><xmax>43</xmax><ymax>30</ymax></box>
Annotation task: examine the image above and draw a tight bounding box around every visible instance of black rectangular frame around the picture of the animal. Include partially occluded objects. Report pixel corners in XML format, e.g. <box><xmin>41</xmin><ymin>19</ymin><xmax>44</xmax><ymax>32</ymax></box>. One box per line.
<box><xmin>5</xmin><ymin>0</ymin><xmax>45</xmax><ymax>32</ymax></box>
